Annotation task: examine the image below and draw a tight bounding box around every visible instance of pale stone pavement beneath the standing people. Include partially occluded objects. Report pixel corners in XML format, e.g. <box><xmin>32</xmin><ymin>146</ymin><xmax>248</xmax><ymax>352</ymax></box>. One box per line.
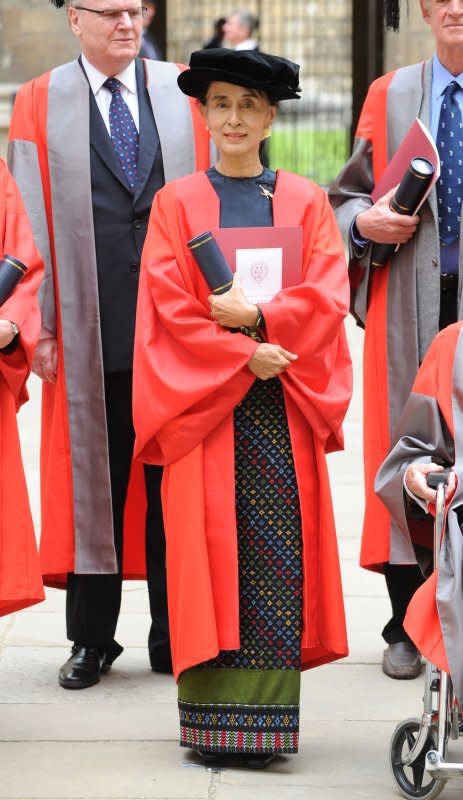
<box><xmin>0</xmin><ymin>322</ymin><xmax>463</xmax><ymax>800</ymax></box>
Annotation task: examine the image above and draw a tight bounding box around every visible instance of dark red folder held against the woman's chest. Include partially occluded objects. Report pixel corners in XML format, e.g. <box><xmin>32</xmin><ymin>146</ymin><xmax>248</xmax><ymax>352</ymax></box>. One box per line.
<box><xmin>211</xmin><ymin>226</ymin><xmax>302</xmax><ymax>300</ymax></box>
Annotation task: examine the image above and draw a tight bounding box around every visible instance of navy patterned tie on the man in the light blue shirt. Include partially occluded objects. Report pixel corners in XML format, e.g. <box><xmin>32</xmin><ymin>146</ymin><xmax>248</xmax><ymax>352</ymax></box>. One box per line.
<box><xmin>436</xmin><ymin>81</ymin><xmax>463</xmax><ymax>245</ymax></box>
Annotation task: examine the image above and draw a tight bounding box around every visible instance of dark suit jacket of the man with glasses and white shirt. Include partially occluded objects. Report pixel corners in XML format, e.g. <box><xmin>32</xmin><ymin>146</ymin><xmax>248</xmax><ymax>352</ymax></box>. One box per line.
<box><xmin>90</xmin><ymin>59</ymin><xmax>164</xmax><ymax>372</ymax></box>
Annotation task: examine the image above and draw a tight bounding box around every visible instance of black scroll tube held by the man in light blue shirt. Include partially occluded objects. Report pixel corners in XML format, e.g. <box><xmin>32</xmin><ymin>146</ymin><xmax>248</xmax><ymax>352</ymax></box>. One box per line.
<box><xmin>371</xmin><ymin>158</ymin><xmax>434</xmax><ymax>267</ymax></box>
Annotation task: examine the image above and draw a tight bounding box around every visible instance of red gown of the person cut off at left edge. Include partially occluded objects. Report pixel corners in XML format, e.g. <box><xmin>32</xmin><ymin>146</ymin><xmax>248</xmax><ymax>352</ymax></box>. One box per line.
<box><xmin>0</xmin><ymin>160</ymin><xmax>44</xmax><ymax>615</ymax></box>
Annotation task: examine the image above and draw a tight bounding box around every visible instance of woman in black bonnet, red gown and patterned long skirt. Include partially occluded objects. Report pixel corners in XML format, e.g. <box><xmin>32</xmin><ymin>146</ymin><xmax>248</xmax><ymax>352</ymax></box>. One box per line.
<box><xmin>134</xmin><ymin>49</ymin><xmax>351</xmax><ymax>766</ymax></box>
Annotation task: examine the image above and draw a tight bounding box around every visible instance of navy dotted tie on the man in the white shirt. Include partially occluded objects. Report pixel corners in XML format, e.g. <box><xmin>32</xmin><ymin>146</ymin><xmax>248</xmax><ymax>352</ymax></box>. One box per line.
<box><xmin>104</xmin><ymin>78</ymin><xmax>138</xmax><ymax>192</ymax></box>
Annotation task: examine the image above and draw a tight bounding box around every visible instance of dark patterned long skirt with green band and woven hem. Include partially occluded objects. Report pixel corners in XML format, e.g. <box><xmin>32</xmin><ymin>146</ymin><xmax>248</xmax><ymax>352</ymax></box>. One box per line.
<box><xmin>178</xmin><ymin>378</ymin><xmax>302</xmax><ymax>754</ymax></box>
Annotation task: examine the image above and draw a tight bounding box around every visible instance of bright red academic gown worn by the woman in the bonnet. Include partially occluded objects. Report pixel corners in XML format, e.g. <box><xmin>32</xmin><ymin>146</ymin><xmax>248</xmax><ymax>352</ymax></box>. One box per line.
<box><xmin>134</xmin><ymin>171</ymin><xmax>351</xmax><ymax>676</ymax></box>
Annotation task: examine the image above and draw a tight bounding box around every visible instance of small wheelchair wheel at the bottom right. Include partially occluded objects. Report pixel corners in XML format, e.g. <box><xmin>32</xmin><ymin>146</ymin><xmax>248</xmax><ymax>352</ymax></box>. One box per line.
<box><xmin>390</xmin><ymin>718</ymin><xmax>447</xmax><ymax>800</ymax></box>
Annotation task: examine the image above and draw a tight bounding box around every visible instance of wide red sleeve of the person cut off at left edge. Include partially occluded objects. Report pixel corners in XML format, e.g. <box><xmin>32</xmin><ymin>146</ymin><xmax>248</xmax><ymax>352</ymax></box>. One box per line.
<box><xmin>0</xmin><ymin>160</ymin><xmax>43</xmax><ymax>407</ymax></box>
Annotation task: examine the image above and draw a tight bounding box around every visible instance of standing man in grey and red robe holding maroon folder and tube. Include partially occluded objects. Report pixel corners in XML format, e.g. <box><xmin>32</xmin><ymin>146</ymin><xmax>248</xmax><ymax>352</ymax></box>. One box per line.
<box><xmin>330</xmin><ymin>0</ymin><xmax>463</xmax><ymax>678</ymax></box>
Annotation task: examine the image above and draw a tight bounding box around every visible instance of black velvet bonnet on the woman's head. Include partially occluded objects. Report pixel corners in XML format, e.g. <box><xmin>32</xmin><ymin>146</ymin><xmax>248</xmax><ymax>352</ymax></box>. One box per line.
<box><xmin>177</xmin><ymin>47</ymin><xmax>301</xmax><ymax>102</ymax></box>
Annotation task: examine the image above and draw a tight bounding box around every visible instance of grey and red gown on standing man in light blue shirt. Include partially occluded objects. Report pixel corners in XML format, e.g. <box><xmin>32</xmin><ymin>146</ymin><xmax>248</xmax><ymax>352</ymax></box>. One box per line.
<box><xmin>330</xmin><ymin>62</ymin><xmax>440</xmax><ymax>572</ymax></box>
